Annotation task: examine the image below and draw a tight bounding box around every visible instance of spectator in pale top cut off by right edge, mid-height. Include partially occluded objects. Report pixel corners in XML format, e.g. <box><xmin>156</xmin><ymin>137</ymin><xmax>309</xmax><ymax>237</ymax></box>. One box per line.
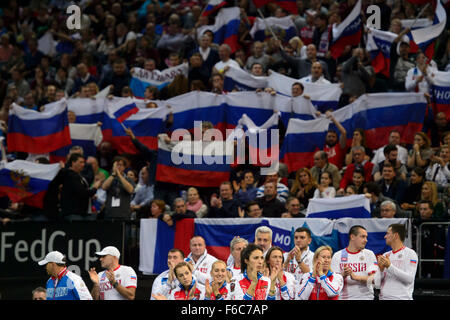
<box><xmin>425</xmin><ymin>144</ymin><xmax>450</xmax><ymax>188</ymax></box>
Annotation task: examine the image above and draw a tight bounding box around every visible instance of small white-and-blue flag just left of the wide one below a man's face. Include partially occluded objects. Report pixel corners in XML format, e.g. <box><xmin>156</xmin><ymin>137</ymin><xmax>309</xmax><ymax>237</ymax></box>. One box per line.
<box><xmin>223</xmin><ymin>67</ymin><xmax>267</xmax><ymax>92</ymax></box>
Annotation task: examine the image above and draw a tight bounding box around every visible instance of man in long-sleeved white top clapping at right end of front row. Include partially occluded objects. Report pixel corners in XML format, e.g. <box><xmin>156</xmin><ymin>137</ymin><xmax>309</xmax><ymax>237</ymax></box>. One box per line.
<box><xmin>374</xmin><ymin>224</ymin><xmax>417</xmax><ymax>300</ymax></box>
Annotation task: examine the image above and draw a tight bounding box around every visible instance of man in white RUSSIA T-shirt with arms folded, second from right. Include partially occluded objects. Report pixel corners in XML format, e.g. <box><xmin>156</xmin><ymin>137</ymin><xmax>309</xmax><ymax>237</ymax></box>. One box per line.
<box><xmin>331</xmin><ymin>225</ymin><xmax>378</xmax><ymax>300</ymax></box>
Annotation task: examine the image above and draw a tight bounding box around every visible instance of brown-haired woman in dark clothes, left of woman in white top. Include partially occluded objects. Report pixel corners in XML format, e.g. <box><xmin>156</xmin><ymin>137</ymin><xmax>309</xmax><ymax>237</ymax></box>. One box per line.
<box><xmin>290</xmin><ymin>168</ymin><xmax>318</xmax><ymax>210</ymax></box>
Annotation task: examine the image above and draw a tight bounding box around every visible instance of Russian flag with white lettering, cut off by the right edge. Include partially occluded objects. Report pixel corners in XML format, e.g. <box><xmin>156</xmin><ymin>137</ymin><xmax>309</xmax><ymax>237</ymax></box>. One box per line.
<box><xmin>431</xmin><ymin>71</ymin><xmax>450</xmax><ymax>120</ymax></box>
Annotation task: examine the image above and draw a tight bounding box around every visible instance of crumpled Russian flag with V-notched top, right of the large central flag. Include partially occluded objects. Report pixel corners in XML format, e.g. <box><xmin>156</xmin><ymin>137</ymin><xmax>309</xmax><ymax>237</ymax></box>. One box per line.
<box><xmin>238</xmin><ymin>113</ymin><xmax>279</xmax><ymax>166</ymax></box>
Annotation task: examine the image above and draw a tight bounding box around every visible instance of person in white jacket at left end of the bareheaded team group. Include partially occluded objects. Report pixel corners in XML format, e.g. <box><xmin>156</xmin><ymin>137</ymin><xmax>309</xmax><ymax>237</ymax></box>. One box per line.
<box><xmin>150</xmin><ymin>249</ymin><xmax>184</xmax><ymax>300</ymax></box>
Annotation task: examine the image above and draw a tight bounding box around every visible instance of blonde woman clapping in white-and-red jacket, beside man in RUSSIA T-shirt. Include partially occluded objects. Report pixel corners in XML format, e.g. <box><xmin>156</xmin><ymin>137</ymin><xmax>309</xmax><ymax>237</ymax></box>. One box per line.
<box><xmin>295</xmin><ymin>246</ymin><xmax>344</xmax><ymax>300</ymax></box>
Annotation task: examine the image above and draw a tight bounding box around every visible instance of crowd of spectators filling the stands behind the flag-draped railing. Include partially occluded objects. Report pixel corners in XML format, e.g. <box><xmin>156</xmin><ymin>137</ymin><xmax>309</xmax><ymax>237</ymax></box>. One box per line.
<box><xmin>0</xmin><ymin>0</ymin><xmax>450</xmax><ymax>230</ymax></box>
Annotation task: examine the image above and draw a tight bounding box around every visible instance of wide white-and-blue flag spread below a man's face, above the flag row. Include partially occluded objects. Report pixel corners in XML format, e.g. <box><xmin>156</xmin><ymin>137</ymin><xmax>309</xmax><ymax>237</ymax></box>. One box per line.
<box><xmin>267</xmin><ymin>70</ymin><xmax>342</xmax><ymax>112</ymax></box>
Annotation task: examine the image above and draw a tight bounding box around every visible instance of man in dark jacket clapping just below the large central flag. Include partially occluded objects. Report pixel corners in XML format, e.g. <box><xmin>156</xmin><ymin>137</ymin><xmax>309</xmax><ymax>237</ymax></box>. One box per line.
<box><xmin>208</xmin><ymin>181</ymin><xmax>241</xmax><ymax>218</ymax></box>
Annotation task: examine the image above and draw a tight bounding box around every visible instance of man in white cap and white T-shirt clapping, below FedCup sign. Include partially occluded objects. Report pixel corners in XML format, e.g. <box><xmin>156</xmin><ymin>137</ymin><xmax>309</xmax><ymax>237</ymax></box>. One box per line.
<box><xmin>89</xmin><ymin>246</ymin><xmax>137</xmax><ymax>300</ymax></box>
